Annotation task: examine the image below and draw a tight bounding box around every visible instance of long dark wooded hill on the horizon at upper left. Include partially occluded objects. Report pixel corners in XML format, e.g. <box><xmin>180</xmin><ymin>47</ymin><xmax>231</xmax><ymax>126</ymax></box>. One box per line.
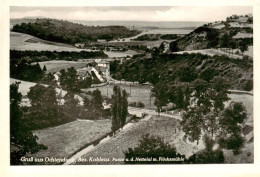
<box><xmin>12</xmin><ymin>19</ymin><xmax>140</xmax><ymax>44</ymax></box>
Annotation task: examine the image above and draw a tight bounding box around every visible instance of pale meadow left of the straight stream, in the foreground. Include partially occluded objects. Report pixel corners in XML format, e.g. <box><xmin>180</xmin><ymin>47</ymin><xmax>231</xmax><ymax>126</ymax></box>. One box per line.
<box><xmin>28</xmin><ymin>120</ymin><xmax>111</xmax><ymax>163</ymax></box>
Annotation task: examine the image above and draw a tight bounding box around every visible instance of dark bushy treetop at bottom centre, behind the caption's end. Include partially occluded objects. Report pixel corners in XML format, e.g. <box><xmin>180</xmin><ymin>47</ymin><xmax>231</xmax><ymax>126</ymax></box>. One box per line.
<box><xmin>125</xmin><ymin>134</ymin><xmax>185</xmax><ymax>164</ymax></box>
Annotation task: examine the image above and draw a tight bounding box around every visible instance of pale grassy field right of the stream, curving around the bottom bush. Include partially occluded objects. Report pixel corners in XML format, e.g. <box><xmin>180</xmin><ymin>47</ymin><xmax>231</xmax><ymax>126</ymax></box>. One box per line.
<box><xmin>78</xmin><ymin>117</ymin><xmax>192</xmax><ymax>164</ymax></box>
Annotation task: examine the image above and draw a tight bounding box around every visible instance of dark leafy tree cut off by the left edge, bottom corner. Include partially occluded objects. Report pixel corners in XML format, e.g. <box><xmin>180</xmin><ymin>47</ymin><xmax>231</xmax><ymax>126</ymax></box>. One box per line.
<box><xmin>10</xmin><ymin>82</ymin><xmax>47</xmax><ymax>165</ymax></box>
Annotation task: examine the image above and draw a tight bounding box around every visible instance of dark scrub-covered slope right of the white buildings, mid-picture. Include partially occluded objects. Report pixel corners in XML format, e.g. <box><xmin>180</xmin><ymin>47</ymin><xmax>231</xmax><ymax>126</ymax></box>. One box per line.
<box><xmin>111</xmin><ymin>54</ymin><xmax>253</xmax><ymax>90</ymax></box>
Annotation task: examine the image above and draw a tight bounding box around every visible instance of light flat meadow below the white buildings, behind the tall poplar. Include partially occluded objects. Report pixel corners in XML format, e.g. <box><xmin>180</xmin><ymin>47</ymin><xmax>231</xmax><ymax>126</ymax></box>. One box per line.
<box><xmin>83</xmin><ymin>81</ymin><xmax>156</xmax><ymax>109</ymax></box>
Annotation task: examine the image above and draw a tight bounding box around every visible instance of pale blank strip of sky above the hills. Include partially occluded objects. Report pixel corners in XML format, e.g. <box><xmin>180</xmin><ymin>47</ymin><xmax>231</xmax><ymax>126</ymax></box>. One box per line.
<box><xmin>10</xmin><ymin>6</ymin><xmax>253</xmax><ymax>22</ymax></box>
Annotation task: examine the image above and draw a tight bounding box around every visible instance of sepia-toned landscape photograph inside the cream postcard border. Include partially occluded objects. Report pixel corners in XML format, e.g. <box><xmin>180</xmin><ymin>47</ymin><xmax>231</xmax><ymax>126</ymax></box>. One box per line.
<box><xmin>9</xmin><ymin>6</ymin><xmax>254</xmax><ymax>165</ymax></box>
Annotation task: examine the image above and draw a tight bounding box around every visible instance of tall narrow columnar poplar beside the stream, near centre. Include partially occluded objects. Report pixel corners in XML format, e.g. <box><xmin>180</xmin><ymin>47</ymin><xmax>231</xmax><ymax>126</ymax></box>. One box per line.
<box><xmin>111</xmin><ymin>86</ymin><xmax>128</xmax><ymax>132</ymax></box>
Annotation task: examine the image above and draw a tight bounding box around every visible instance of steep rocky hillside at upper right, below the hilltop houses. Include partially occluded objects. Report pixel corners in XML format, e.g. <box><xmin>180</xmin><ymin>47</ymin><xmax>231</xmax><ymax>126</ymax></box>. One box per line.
<box><xmin>170</xmin><ymin>15</ymin><xmax>253</xmax><ymax>52</ymax></box>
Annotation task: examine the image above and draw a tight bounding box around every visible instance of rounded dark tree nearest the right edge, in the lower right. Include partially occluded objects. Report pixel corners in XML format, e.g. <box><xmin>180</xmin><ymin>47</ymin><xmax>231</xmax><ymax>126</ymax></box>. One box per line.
<box><xmin>219</xmin><ymin>102</ymin><xmax>248</xmax><ymax>154</ymax></box>
